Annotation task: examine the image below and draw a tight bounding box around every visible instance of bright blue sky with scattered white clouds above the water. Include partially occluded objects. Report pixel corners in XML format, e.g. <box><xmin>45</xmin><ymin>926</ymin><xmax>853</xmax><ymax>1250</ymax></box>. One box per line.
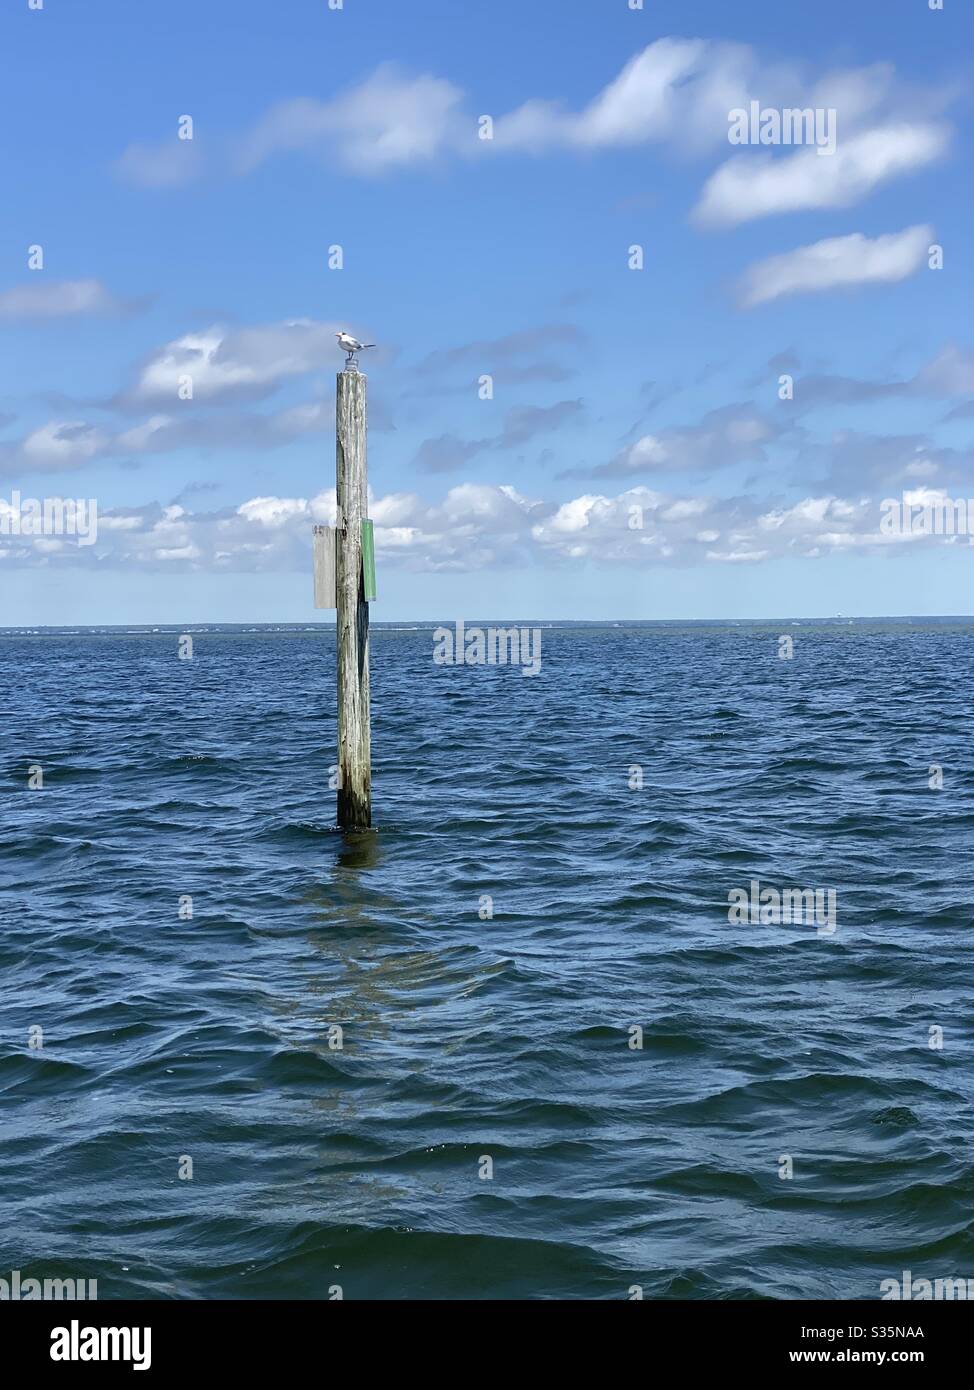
<box><xmin>0</xmin><ymin>0</ymin><xmax>974</xmax><ymax>624</ymax></box>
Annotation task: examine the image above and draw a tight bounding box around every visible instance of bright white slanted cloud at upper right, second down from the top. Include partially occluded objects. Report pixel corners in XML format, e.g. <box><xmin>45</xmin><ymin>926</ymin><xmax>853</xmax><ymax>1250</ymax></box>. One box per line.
<box><xmin>693</xmin><ymin>124</ymin><xmax>949</xmax><ymax>225</ymax></box>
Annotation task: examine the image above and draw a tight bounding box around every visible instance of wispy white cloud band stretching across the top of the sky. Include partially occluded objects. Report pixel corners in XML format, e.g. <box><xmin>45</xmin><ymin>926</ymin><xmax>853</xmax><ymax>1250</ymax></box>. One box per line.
<box><xmin>117</xmin><ymin>38</ymin><xmax>949</xmax><ymax>188</ymax></box>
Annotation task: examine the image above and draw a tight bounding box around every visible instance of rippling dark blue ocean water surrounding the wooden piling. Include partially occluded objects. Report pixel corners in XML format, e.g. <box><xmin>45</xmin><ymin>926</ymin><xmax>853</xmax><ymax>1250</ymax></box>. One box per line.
<box><xmin>0</xmin><ymin>620</ymin><xmax>974</xmax><ymax>1298</ymax></box>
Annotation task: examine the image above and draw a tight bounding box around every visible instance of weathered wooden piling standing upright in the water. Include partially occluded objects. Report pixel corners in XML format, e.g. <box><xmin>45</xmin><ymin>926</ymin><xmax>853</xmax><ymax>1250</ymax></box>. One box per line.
<box><xmin>335</xmin><ymin>368</ymin><xmax>372</xmax><ymax>830</ymax></box>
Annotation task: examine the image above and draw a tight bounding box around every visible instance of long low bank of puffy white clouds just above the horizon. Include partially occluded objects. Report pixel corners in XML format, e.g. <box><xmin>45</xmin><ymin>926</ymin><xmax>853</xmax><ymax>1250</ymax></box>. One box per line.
<box><xmin>0</xmin><ymin>472</ymin><xmax>967</xmax><ymax>569</ymax></box>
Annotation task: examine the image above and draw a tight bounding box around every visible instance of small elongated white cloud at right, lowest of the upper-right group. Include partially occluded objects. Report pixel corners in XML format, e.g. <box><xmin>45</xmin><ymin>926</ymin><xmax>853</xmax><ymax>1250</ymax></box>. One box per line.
<box><xmin>739</xmin><ymin>227</ymin><xmax>934</xmax><ymax>309</ymax></box>
